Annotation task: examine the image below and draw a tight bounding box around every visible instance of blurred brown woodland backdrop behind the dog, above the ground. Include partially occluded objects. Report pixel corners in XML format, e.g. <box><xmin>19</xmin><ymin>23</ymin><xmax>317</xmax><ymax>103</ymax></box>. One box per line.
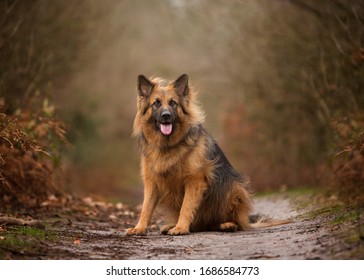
<box><xmin>0</xmin><ymin>0</ymin><xmax>364</xmax><ymax>208</ymax></box>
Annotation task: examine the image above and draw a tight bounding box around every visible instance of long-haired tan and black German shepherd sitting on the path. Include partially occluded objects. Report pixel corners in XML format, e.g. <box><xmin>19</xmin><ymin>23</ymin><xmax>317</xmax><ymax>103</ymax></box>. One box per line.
<box><xmin>127</xmin><ymin>74</ymin><xmax>252</xmax><ymax>235</ymax></box>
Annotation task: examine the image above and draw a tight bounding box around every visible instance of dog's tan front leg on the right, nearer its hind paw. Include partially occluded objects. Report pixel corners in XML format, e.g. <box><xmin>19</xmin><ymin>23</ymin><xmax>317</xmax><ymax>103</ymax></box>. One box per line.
<box><xmin>168</xmin><ymin>176</ymin><xmax>207</xmax><ymax>235</ymax></box>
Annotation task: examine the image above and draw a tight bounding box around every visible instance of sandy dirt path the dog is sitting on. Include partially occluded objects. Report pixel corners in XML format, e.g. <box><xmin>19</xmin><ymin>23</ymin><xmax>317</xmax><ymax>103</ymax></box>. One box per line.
<box><xmin>39</xmin><ymin>197</ymin><xmax>358</xmax><ymax>259</ymax></box>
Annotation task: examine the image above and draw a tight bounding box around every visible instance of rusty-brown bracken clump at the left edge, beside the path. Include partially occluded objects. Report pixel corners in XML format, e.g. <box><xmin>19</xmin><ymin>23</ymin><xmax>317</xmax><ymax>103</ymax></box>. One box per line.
<box><xmin>0</xmin><ymin>110</ymin><xmax>66</xmax><ymax>208</ymax></box>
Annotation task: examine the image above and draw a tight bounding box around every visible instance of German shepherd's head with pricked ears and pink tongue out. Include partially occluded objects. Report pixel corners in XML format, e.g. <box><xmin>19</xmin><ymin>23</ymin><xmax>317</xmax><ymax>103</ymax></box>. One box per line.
<box><xmin>134</xmin><ymin>74</ymin><xmax>203</xmax><ymax>145</ymax></box>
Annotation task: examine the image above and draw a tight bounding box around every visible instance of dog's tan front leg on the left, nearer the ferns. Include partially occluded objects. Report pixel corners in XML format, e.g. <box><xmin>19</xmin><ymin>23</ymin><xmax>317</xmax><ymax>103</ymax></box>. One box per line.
<box><xmin>126</xmin><ymin>181</ymin><xmax>159</xmax><ymax>235</ymax></box>
